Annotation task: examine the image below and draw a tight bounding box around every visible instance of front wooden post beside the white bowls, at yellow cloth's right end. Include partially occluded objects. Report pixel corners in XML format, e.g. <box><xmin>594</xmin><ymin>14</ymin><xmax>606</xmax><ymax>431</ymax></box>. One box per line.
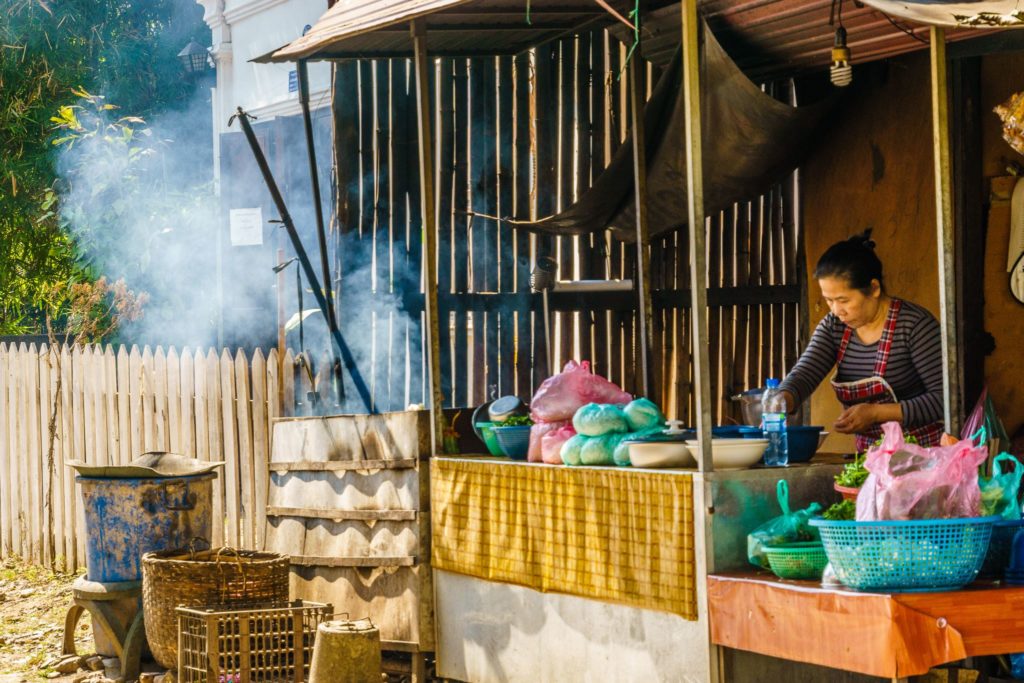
<box><xmin>682</xmin><ymin>0</ymin><xmax>715</xmax><ymax>472</ymax></box>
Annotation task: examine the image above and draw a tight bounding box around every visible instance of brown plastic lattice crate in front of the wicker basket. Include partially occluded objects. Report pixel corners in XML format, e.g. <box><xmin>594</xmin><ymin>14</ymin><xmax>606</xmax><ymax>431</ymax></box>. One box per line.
<box><xmin>177</xmin><ymin>600</ymin><xmax>334</xmax><ymax>683</ymax></box>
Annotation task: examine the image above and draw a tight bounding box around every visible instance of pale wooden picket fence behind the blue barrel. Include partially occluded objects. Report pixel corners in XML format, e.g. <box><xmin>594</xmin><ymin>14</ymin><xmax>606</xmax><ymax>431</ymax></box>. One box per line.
<box><xmin>0</xmin><ymin>344</ymin><xmax>295</xmax><ymax>569</ymax></box>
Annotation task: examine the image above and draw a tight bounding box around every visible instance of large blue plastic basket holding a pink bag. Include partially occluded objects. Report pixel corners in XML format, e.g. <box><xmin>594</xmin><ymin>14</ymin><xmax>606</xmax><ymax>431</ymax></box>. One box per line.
<box><xmin>811</xmin><ymin>517</ymin><xmax>999</xmax><ymax>592</ymax></box>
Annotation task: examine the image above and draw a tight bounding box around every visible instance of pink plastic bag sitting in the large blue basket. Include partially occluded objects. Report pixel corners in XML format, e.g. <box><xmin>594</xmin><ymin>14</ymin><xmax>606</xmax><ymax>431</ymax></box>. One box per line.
<box><xmin>857</xmin><ymin>422</ymin><xmax>988</xmax><ymax>521</ymax></box>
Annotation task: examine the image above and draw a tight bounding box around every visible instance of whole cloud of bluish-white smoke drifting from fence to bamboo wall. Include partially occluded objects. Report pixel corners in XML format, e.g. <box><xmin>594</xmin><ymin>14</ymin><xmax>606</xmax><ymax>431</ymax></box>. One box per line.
<box><xmin>57</xmin><ymin>6</ymin><xmax>424</xmax><ymax>413</ymax></box>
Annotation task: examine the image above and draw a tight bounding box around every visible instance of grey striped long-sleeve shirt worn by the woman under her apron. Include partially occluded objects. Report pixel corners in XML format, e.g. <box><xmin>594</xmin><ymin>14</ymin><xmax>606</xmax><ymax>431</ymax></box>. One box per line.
<box><xmin>779</xmin><ymin>301</ymin><xmax>943</xmax><ymax>427</ymax></box>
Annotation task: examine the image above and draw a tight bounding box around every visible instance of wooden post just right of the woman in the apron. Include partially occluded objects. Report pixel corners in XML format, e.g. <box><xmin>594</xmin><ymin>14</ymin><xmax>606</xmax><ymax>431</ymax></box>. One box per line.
<box><xmin>931</xmin><ymin>27</ymin><xmax>962</xmax><ymax>434</ymax></box>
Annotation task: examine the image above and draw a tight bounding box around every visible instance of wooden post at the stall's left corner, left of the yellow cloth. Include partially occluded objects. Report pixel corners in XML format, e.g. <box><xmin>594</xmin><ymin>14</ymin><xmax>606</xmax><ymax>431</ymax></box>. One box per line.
<box><xmin>410</xmin><ymin>22</ymin><xmax>444</xmax><ymax>454</ymax></box>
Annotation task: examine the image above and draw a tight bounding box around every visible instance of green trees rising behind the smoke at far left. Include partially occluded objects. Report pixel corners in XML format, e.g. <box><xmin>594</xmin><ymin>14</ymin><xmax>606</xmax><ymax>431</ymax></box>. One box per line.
<box><xmin>0</xmin><ymin>0</ymin><xmax>207</xmax><ymax>334</ymax></box>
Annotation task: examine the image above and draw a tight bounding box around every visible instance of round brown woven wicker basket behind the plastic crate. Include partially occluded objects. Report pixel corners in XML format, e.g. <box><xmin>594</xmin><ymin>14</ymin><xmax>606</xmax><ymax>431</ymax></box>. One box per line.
<box><xmin>142</xmin><ymin>548</ymin><xmax>289</xmax><ymax>669</ymax></box>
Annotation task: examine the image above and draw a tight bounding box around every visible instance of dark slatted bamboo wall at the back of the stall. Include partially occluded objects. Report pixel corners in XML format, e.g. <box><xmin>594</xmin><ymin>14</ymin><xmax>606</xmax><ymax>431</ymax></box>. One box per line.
<box><xmin>332</xmin><ymin>32</ymin><xmax>804</xmax><ymax>428</ymax></box>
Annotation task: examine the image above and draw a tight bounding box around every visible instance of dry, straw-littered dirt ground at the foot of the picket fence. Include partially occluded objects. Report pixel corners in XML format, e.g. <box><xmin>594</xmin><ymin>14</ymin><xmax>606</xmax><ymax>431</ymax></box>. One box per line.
<box><xmin>0</xmin><ymin>560</ymin><xmax>94</xmax><ymax>683</ymax></box>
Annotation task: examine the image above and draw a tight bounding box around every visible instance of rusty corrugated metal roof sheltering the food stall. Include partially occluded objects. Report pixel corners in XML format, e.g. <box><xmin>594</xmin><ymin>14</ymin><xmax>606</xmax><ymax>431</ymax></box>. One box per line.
<box><xmin>271</xmin><ymin>0</ymin><xmax>999</xmax><ymax>77</ymax></box>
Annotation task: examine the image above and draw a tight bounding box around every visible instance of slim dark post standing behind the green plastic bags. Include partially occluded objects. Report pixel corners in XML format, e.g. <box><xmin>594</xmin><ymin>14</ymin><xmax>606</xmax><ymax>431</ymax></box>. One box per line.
<box><xmin>630</xmin><ymin>54</ymin><xmax>662</xmax><ymax>404</ymax></box>
